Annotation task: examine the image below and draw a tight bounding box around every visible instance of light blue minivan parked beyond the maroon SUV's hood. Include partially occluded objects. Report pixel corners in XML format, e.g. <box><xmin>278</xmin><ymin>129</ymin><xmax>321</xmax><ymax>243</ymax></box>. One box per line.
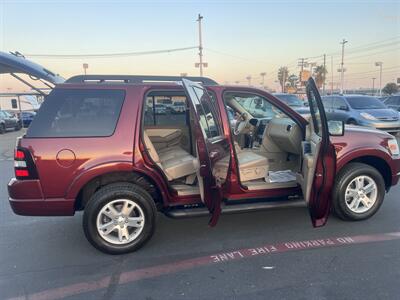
<box><xmin>322</xmin><ymin>95</ymin><xmax>400</xmax><ymax>133</ymax></box>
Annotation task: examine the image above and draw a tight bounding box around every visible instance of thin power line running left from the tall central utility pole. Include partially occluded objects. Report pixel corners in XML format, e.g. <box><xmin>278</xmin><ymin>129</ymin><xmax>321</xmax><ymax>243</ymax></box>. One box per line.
<box><xmin>25</xmin><ymin>46</ymin><xmax>198</xmax><ymax>59</ymax></box>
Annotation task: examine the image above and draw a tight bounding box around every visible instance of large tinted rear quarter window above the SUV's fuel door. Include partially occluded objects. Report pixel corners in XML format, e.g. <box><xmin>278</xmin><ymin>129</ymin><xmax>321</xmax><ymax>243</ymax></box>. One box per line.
<box><xmin>27</xmin><ymin>89</ymin><xmax>125</xmax><ymax>137</ymax></box>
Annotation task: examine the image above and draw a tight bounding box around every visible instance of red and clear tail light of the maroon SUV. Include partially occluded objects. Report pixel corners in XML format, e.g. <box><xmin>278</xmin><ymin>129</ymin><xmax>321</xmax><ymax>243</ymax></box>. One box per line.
<box><xmin>14</xmin><ymin>147</ymin><xmax>38</xmax><ymax>180</ymax></box>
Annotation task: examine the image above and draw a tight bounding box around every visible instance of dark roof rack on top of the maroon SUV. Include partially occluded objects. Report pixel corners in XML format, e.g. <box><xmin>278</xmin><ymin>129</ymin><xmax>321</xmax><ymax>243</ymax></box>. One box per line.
<box><xmin>65</xmin><ymin>75</ymin><xmax>218</xmax><ymax>85</ymax></box>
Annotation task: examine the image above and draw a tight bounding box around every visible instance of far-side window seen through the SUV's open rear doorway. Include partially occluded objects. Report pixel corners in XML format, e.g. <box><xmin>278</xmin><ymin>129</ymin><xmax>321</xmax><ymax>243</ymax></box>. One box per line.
<box><xmin>144</xmin><ymin>92</ymin><xmax>187</xmax><ymax>126</ymax></box>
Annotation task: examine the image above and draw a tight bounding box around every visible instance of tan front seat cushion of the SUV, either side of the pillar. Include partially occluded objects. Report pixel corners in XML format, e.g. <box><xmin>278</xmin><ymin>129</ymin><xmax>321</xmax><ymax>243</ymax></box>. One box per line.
<box><xmin>213</xmin><ymin>150</ymin><xmax>268</xmax><ymax>182</ymax></box>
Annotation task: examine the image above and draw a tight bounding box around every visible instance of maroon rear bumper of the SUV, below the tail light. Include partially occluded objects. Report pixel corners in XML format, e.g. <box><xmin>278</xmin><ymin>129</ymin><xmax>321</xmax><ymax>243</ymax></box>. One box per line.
<box><xmin>8</xmin><ymin>178</ymin><xmax>75</xmax><ymax>216</ymax></box>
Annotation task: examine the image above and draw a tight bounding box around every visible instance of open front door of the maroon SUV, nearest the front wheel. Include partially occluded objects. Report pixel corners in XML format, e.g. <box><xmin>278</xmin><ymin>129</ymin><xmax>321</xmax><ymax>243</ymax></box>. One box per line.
<box><xmin>303</xmin><ymin>78</ymin><xmax>336</xmax><ymax>227</ymax></box>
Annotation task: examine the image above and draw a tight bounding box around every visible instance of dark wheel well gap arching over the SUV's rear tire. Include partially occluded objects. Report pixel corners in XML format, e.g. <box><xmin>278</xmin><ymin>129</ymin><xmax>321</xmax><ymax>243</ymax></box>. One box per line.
<box><xmin>75</xmin><ymin>172</ymin><xmax>162</xmax><ymax>210</ymax></box>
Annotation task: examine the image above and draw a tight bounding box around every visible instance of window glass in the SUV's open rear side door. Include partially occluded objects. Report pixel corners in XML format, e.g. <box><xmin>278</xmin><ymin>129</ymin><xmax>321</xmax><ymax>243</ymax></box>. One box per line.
<box><xmin>193</xmin><ymin>87</ymin><xmax>221</xmax><ymax>138</ymax></box>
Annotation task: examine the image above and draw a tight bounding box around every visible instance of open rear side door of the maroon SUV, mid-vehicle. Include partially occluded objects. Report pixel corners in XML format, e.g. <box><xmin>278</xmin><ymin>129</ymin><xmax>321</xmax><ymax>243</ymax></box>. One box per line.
<box><xmin>182</xmin><ymin>79</ymin><xmax>222</xmax><ymax>226</ymax></box>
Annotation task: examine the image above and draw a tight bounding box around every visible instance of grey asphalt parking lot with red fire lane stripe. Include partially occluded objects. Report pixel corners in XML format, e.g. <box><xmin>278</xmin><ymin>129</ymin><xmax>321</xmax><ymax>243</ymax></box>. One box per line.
<box><xmin>0</xmin><ymin>131</ymin><xmax>400</xmax><ymax>299</ymax></box>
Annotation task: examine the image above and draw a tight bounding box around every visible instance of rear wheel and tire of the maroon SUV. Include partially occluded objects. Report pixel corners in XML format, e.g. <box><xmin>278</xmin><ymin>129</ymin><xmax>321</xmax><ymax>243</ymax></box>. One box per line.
<box><xmin>83</xmin><ymin>183</ymin><xmax>157</xmax><ymax>254</ymax></box>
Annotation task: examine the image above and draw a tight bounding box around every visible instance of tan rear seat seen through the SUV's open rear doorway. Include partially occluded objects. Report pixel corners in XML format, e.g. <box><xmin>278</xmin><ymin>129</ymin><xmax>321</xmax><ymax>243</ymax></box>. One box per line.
<box><xmin>143</xmin><ymin>131</ymin><xmax>198</xmax><ymax>181</ymax></box>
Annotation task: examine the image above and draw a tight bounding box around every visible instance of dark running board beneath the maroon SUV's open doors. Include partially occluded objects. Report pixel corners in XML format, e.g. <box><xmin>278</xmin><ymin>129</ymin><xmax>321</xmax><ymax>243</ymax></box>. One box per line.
<box><xmin>164</xmin><ymin>199</ymin><xmax>306</xmax><ymax>219</ymax></box>
